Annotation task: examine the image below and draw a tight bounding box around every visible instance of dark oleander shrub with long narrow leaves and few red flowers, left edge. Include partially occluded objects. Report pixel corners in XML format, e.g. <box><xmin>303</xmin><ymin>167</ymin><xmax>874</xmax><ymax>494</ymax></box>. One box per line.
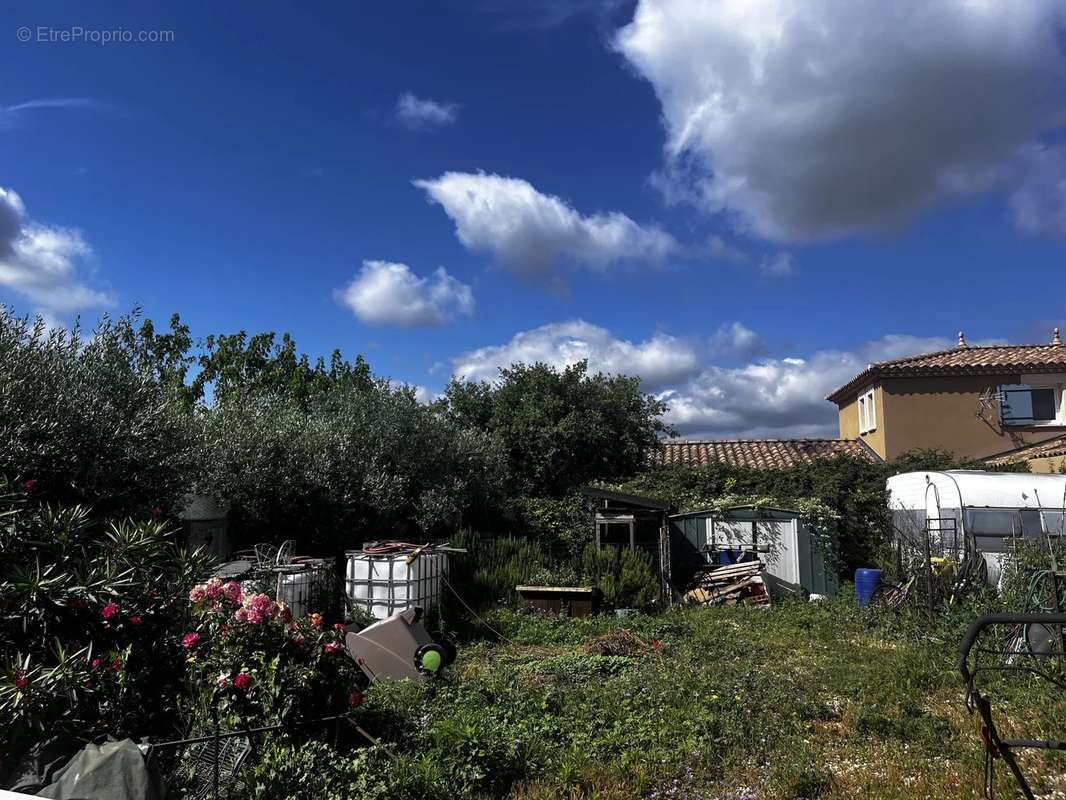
<box><xmin>0</xmin><ymin>480</ymin><xmax>214</xmax><ymax>768</ymax></box>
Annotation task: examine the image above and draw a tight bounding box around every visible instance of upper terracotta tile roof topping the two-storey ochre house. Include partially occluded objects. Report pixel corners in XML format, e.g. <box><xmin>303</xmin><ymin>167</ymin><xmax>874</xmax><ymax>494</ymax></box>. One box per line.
<box><xmin>825</xmin><ymin>345</ymin><xmax>1066</xmax><ymax>402</ymax></box>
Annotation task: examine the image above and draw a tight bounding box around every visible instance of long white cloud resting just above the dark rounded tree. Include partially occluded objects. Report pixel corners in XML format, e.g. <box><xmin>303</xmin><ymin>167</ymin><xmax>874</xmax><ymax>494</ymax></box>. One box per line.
<box><xmin>452</xmin><ymin>320</ymin><xmax>699</xmax><ymax>389</ymax></box>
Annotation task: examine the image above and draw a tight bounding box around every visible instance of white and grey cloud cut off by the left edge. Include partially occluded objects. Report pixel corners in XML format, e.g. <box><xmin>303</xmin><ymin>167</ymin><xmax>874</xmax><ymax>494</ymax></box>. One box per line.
<box><xmin>0</xmin><ymin>187</ymin><xmax>113</xmax><ymax>317</ymax></box>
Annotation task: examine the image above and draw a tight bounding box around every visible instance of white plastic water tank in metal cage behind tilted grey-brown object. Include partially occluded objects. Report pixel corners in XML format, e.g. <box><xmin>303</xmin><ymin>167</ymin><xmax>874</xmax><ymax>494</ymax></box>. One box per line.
<box><xmin>344</xmin><ymin>550</ymin><xmax>448</xmax><ymax>620</ymax></box>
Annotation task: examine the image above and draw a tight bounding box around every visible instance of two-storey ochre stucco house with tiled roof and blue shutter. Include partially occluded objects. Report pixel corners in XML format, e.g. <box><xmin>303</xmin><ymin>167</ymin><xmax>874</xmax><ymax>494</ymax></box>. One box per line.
<box><xmin>826</xmin><ymin>327</ymin><xmax>1066</xmax><ymax>471</ymax></box>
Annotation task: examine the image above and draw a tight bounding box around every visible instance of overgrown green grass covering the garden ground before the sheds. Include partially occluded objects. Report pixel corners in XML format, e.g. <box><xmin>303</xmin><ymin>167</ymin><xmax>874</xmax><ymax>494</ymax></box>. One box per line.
<box><xmin>239</xmin><ymin>597</ymin><xmax>1066</xmax><ymax>800</ymax></box>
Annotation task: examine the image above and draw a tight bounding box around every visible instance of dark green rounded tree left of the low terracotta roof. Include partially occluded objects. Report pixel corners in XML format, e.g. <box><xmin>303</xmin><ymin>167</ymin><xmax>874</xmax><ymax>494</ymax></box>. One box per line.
<box><xmin>440</xmin><ymin>362</ymin><xmax>667</xmax><ymax>497</ymax></box>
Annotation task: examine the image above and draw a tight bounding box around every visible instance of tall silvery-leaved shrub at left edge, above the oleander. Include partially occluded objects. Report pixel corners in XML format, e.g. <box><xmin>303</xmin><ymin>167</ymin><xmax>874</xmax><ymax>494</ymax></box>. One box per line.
<box><xmin>0</xmin><ymin>306</ymin><xmax>196</xmax><ymax>517</ymax></box>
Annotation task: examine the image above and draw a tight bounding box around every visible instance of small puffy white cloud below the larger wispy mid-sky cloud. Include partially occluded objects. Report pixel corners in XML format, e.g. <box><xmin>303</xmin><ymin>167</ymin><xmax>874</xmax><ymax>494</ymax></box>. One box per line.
<box><xmin>337</xmin><ymin>261</ymin><xmax>474</xmax><ymax>327</ymax></box>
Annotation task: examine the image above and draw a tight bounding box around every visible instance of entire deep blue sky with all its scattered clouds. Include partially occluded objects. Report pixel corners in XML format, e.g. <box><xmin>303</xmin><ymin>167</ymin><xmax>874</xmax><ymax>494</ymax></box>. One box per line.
<box><xmin>0</xmin><ymin>0</ymin><xmax>1066</xmax><ymax>436</ymax></box>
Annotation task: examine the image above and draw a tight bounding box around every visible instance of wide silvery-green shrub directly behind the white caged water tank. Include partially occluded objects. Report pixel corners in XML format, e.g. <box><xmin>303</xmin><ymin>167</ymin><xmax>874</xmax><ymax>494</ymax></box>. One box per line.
<box><xmin>205</xmin><ymin>382</ymin><xmax>505</xmax><ymax>553</ymax></box>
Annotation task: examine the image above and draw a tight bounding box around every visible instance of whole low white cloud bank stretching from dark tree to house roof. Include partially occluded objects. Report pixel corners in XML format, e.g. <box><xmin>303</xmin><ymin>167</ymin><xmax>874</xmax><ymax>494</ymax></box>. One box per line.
<box><xmin>452</xmin><ymin>320</ymin><xmax>999</xmax><ymax>438</ymax></box>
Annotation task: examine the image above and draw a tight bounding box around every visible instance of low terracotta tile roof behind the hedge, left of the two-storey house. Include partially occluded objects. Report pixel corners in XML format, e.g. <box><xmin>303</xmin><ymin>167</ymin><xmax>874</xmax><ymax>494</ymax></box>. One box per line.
<box><xmin>651</xmin><ymin>438</ymin><xmax>879</xmax><ymax>469</ymax></box>
